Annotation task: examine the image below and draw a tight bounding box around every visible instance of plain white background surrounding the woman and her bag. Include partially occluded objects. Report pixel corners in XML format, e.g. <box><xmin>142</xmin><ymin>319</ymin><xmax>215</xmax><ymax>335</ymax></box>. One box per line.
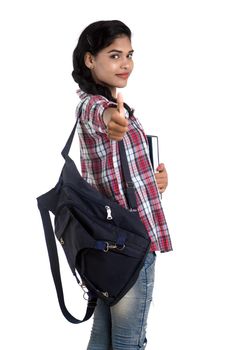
<box><xmin>0</xmin><ymin>0</ymin><xmax>234</xmax><ymax>350</ymax></box>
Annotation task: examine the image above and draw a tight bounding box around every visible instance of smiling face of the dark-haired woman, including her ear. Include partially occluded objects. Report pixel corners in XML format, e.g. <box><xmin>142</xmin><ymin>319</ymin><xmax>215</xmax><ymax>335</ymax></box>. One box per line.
<box><xmin>85</xmin><ymin>36</ymin><xmax>133</xmax><ymax>97</ymax></box>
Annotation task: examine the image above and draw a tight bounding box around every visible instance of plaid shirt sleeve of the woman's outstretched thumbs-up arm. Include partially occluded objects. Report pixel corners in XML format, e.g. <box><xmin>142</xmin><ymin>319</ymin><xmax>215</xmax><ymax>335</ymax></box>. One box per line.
<box><xmin>81</xmin><ymin>96</ymin><xmax>116</xmax><ymax>134</ymax></box>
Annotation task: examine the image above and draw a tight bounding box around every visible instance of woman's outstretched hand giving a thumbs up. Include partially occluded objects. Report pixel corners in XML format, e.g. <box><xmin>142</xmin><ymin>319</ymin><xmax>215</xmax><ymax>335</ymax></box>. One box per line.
<box><xmin>104</xmin><ymin>93</ymin><xmax>128</xmax><ymax>141</ymax></box>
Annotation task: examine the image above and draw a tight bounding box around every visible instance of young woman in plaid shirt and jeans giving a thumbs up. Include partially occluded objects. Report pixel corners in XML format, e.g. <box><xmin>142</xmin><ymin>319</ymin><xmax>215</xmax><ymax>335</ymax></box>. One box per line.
<box><xmin>72</xmin><ymin>20</ymin><xmax>172</xmax><ymax>350</ymax></box>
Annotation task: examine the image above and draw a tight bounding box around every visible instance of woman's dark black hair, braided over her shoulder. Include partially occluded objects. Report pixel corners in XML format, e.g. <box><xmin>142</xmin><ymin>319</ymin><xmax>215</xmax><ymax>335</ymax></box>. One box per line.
<box><xmin>72</xmin><ymin>20</ymin><xmax>131</xmax><ymax>101</ymax></box>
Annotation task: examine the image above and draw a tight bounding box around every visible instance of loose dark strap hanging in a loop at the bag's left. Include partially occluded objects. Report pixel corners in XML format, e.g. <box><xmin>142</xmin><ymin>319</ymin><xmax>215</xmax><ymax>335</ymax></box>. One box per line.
<box><xmin>37</xmin><ymin>189</ymin><xmax>97</xmax><ymax>324</ymax></box>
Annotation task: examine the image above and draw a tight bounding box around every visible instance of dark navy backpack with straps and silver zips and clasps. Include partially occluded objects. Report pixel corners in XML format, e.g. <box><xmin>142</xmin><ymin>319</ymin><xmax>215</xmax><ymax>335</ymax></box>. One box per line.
<box><xmin>37</xmin><ymin>108</ymin><xmax>150</xmax><ymax>323</ymax></box>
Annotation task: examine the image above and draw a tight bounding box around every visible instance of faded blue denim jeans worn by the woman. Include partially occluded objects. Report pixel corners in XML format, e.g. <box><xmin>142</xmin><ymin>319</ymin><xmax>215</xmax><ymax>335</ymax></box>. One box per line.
<box><xmin>87</xmin><ymin>253</ymin><xmax>156</xmax><ymax>350</ymax></box>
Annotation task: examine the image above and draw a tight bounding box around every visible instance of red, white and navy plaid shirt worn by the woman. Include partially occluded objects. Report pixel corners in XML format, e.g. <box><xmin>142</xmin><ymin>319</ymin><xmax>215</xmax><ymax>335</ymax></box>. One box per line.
<box><xmin>77</xmin><ymin>90</ymin><xmax>172</xmax><ymax>252</ymax></box>
